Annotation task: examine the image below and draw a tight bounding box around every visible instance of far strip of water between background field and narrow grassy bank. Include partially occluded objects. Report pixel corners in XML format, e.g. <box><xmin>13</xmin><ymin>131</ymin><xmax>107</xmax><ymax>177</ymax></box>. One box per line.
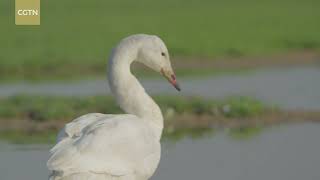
<box><xmin>0</xmin><ymin>67</ymin><xmax>320</xmax><ymax>110</ymax></box>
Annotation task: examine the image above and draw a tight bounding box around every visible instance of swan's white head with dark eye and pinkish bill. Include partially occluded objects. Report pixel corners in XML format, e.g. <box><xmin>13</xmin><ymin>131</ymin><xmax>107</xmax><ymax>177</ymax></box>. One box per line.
<box><xmin>137</xmin><ymin>35</ymin><xmax>181</xmax><ymax>91</ymax></box>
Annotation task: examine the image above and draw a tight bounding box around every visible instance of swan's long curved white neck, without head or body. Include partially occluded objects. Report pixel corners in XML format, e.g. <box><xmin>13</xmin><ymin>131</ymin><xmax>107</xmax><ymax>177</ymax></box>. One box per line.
<box><xmin>108</xmin><ymin>44</ymin><xmax>163</xmax><ymax>135</ymax></box>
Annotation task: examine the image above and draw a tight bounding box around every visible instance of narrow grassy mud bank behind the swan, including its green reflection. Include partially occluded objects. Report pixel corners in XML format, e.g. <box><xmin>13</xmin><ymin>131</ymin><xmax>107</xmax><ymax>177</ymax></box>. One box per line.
<box><xmin>0</xmin><ymin>96</ymin><xmax>320</xmax><ymax>143</ymax></box>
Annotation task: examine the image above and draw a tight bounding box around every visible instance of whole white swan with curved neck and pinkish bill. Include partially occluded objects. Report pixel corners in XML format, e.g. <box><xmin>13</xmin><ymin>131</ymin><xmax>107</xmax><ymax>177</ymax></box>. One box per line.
<box><xmin>47</xmin><ymin>34</ymin><xmax>180</xmax><ymax>180</ymax></box>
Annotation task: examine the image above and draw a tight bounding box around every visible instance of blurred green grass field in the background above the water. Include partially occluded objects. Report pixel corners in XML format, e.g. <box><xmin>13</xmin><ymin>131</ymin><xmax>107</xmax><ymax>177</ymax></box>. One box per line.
<box><xmin>0</xmin><ymin>0</ymin><xmax>320</xmax><ymax>80</ymax></box>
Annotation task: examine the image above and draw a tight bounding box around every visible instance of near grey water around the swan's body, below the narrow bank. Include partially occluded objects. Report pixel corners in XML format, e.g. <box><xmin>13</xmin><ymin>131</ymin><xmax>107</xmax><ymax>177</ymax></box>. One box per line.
<box><xmin>0</xmin><ymin>123</ymin><xmax>320</xmax><ymax>180</ymax></box>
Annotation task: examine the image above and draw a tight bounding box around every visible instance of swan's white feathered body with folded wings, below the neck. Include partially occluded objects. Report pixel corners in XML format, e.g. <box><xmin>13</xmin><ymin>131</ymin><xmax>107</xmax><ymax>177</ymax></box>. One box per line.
<box><xmin>47</xmin><ymin>113</ymin><xmax>160</xmax><ymax>180</ymax></box>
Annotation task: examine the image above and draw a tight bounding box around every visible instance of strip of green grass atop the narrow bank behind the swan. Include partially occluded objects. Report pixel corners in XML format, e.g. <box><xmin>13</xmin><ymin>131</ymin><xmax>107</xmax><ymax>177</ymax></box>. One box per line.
<box><xmin>0</xmin><ymin>96</ymin><xmax>268</xmax><ymax>122</ymax></box>
